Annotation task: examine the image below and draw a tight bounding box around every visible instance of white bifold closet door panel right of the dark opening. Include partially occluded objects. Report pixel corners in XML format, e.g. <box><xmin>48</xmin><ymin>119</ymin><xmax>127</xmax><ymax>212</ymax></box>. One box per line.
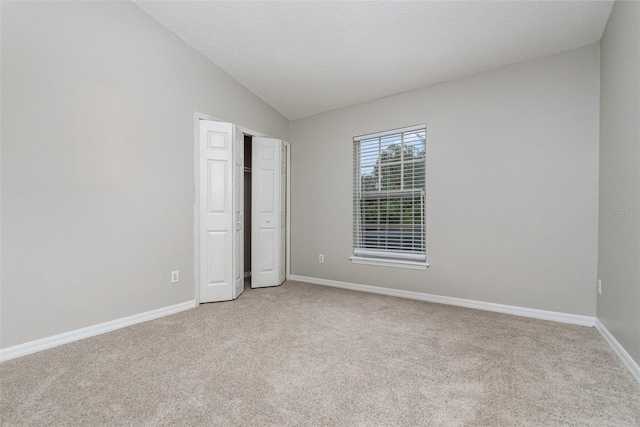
<box><xmin>251</xmin><ymin>137</ymin><xmax>284</xmax><ymax>288</ymax></box>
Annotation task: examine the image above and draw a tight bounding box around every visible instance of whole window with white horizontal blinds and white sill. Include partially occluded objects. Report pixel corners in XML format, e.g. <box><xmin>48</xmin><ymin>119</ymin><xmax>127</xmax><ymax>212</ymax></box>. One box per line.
<box><xmin>351</xmin><ymin>125</ymin><xmax>426</xmax><ymax>268</ymax></box>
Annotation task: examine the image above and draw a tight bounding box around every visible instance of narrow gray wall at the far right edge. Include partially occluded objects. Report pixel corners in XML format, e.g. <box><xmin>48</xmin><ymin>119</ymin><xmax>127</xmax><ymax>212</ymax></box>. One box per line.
<box><xmin>598</xmin><ymin>1</ymin><xmax>640</xmax><ymax>364</ymax></box>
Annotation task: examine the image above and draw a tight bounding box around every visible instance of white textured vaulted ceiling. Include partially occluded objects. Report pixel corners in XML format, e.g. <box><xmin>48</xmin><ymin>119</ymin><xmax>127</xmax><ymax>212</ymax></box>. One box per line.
<box><xmin>136</xmin><ymin>1</ymin><xmax>613</xmax><ymax>120</ymax></box>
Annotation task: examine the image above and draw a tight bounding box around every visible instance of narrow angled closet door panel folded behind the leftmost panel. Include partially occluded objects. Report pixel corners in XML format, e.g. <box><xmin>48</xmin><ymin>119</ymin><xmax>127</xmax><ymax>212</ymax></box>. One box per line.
<box><xmin>233</xmin><ymin>126</ymin><xmax>244</xmax><ymax>299</ymax></box>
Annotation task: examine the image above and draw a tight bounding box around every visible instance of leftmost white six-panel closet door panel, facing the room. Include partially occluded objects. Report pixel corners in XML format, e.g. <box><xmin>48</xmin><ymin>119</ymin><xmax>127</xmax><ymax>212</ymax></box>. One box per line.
<box><xmin>199</xmin><ymin>120</ymin><xmax>234</xmax><ymax>303</ymax></box>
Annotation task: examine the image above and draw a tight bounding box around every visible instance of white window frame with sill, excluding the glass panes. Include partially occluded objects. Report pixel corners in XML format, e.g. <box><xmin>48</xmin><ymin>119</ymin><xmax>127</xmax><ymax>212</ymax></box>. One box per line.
<box><xmin>349</xmin><ymin>124</ymin><xmax>429</xmax><ymax>270</ymax></box>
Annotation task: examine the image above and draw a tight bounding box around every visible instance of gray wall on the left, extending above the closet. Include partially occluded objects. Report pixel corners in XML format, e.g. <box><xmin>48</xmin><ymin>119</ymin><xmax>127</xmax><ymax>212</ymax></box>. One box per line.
<box><xmin>0</xmin><ymin>2</ymin><xmax>289</xmax><ymax>348</ymax></box>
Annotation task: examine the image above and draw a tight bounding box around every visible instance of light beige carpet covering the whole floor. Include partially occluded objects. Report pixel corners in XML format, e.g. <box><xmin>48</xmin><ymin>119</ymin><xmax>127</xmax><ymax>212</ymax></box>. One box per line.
<box><xmin>0</xmin><ymin>282</ymin><xmax>640</xmax><ymax>426</ymax></box>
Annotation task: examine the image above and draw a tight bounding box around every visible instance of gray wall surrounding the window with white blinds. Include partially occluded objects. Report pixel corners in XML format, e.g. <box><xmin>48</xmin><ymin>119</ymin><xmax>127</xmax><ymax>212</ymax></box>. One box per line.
<box><xmin>291</xmin><ymin>44</ymin><xmax>599</xmax><ymax>316</ymax></box>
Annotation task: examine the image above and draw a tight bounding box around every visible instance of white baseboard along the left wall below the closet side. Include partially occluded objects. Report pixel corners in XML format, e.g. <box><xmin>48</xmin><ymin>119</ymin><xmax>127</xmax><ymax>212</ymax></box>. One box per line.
<box><xmin>0</xmin><ymin>300</ymin><xmax>196</xmax><ymax>362</ymax></box>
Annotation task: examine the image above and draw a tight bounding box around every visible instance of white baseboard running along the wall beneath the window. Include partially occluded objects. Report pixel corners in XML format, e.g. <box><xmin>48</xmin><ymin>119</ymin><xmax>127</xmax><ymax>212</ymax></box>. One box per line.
<box><xmin>291</xmin><ymin>274</ymin><xmax>595</xmax><ymax>327</ymax></box>
